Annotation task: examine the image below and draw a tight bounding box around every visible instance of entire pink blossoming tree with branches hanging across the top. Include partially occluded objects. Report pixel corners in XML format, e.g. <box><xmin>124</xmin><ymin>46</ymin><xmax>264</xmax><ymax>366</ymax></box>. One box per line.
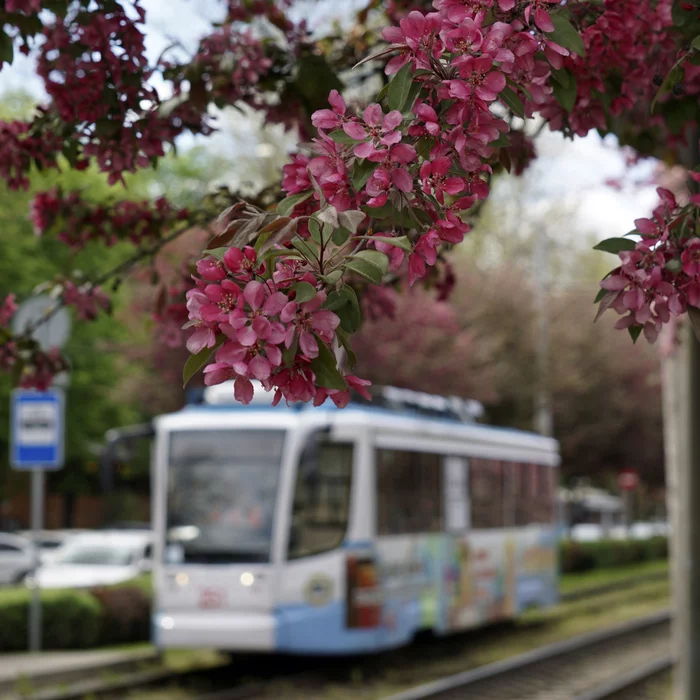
<box><xmin>0</xmin><ymin>0</ymin><xmax>700</xmax><ymax>406</ymax></box>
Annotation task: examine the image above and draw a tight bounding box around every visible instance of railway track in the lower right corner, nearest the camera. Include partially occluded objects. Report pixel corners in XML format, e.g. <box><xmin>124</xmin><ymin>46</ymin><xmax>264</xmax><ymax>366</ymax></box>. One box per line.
<box><xmin>384</xmin><ymin>611</ymin><xmax>671</xmax><ymax>700</ymax></box>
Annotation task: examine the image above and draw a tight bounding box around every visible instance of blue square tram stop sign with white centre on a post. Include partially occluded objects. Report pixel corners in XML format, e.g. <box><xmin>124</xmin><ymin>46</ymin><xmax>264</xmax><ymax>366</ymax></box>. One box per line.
<box><xmin>10</xmin><ymin>389</ymin><xmax>64</xmax><ymax>469</ymax></box>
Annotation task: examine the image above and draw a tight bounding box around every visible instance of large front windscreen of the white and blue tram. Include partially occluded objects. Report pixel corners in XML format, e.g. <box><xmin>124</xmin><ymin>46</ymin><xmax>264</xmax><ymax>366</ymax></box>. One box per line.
<box><xmin>165</xmin><ymin>430</ymin><xmax>285</xmax><ymax>564</ymax></box>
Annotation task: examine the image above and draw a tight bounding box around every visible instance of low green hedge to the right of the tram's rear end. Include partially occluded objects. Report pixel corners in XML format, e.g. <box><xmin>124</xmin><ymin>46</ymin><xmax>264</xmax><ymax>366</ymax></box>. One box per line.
<box><xmin>559</xmin><ymin>537</ymin><xmax>668</xmax><ymax>574</ymax></box>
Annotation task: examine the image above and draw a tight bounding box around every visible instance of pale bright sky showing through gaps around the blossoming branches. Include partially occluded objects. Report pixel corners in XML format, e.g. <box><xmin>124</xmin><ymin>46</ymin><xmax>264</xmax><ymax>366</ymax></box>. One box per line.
<box><xmin>0</xmin><ymin>0</ymin><xmax>656</xmax><ymax>246</ymax></box>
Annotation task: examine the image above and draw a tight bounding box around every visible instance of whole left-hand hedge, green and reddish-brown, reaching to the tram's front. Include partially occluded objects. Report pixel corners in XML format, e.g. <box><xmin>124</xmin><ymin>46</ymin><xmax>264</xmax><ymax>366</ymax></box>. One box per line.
<box><xmin>0</xmin><ymin>584</ymin><xmax>151</xmax><ymax>653</ymax></box>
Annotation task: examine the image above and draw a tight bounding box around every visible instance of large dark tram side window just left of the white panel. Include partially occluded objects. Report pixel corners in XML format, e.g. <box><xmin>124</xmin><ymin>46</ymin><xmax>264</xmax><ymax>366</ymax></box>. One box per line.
<box><xmin>377</xmin><ymin>450</ymin><xmax>443</xmax><ymax>535</ymax></box>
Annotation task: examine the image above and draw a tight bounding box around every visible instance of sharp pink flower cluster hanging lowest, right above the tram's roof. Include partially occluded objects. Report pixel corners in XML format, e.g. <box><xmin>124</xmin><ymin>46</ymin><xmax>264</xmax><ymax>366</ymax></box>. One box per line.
<box><xmin>186</xmin><ymin>247</ymin><xmax>366</xmax><ymax>404</ymax></box>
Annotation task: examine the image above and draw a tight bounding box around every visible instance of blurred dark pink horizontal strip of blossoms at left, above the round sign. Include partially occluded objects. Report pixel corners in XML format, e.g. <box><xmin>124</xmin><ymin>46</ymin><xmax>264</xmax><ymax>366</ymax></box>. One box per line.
<box><xmin>31</xmin><ymin>188</ymin><xmax>189</xmax><ymax>250</ymax></box>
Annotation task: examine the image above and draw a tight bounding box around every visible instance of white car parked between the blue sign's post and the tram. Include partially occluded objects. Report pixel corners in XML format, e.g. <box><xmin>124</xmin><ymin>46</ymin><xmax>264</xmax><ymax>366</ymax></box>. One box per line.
<box><xmin>36</xmin><ymin>531</ymin><xmax>152</xmax><ymax>588</ymax></box>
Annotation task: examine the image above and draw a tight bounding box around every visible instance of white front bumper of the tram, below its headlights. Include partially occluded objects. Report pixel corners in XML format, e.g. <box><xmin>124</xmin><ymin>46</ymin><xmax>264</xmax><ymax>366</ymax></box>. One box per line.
<box><xmin>153</xmin><ymin>610</ymin><xmax>275</xmax><ymax>651</ymax></box>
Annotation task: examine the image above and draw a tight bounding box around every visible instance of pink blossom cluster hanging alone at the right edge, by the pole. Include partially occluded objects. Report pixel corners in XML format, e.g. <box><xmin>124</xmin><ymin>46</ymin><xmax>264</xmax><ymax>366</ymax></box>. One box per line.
<box><xmin>600</xmin><ymin>189</ymin><xmax>700</xmax><ymax>343</ymax></box>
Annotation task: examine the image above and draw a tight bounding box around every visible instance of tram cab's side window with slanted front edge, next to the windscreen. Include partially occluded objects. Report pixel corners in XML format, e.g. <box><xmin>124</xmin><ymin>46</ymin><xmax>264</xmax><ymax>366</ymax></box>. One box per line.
<box><xmin>289</xmin><ymin>443</ymin><xmax>353</xmax><ymax>559</ymax></box>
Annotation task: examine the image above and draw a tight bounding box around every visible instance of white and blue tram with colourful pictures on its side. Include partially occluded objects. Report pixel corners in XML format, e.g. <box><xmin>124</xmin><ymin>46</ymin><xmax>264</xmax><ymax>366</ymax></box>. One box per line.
<box><xmin>153</xmin><ymin>384</ymin><xmax>559</xmax><ymax>654</ymax></box>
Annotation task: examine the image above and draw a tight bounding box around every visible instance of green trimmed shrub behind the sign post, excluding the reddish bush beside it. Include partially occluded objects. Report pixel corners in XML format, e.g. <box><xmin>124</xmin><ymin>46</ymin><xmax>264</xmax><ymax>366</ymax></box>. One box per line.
<box><xmin>0</xmin><ymin>588</ymin><xmax>101</xmax><ymax>652</ymax></box>
